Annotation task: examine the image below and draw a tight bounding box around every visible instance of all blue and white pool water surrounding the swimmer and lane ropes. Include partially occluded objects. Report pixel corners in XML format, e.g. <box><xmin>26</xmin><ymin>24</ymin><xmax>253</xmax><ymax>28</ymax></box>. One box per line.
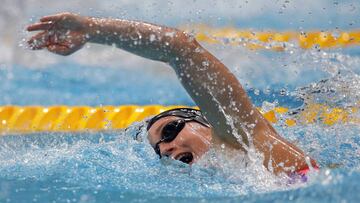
<box><xmin>0</xmin><ymin>0</ymin><xmax>360</xmax><ymax>203</ymax></box>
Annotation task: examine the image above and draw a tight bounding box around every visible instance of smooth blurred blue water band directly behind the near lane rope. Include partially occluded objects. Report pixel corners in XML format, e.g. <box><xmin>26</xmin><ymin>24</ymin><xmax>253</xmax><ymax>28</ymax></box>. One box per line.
<box><xmin>0</xmin><ymin>64</ymin><xmax>302</xmax><ymax>107</ymax></box>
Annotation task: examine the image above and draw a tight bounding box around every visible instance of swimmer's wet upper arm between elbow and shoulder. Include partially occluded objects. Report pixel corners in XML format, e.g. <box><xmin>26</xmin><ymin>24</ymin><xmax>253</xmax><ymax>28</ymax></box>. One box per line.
<box><xmin>171</xmin><ymin>40</ymin><xmax>257</xmax><ymax>150</ymax></box>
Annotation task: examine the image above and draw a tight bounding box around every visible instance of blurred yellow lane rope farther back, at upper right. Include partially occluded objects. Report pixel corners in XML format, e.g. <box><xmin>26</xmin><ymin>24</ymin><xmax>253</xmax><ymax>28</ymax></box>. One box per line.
<box><xmin>182</xmin><ymin>25</ymin><xmax>360</xmax><ymax>51</ymax></box>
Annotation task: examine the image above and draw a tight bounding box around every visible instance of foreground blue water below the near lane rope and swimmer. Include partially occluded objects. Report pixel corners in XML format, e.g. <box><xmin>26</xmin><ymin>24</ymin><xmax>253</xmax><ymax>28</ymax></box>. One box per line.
<box><xmin>0</xmin><ymin>125</ymin><xmax>360</xmax><ymax>202</ymax></box>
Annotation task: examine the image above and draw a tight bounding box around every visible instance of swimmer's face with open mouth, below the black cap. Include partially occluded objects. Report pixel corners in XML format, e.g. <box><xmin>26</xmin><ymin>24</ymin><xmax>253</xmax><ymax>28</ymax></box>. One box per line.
<box><xmin>148</xmin><ymin>116</ymin><xmax>211</xmax><ymax>164</ymax></box>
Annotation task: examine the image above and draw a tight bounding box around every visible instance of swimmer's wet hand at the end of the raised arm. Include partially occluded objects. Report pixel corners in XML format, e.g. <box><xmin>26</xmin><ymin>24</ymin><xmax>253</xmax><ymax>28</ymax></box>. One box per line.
<box><xmin>27</xmin><ymin>13</ymin><xmax>89</xmax><ymax>56</ymax></box>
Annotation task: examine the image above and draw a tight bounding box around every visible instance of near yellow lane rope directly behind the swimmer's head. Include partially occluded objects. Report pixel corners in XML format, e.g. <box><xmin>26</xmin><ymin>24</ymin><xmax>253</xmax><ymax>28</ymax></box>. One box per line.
<box><xmin>0</xmin><ymin>104</ymin><xmax>360</xmax><ymax>134</ymax></box>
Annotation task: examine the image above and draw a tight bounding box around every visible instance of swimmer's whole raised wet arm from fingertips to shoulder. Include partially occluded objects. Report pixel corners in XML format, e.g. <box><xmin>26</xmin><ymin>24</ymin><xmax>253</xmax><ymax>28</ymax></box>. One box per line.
<box><xmin>28</xmin><ymin>13</ymin><xmax>316</xmax><ymax>173</ymax></box>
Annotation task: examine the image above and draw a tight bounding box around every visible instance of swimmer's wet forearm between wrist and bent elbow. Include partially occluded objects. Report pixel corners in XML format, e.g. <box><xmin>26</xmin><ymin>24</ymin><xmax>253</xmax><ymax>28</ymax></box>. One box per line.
<box><xmin>88</xmin><ymin>18</ymin><xmax>183</xmax><ymax>62</ymax></box>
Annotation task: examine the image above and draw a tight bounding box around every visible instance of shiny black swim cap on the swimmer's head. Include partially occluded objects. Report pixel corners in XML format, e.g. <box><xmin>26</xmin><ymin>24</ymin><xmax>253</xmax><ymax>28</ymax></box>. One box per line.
<box><xmin>146</xmin><ymin>108</ymin><xmax>211</xmax><ymax>130</ymax></box>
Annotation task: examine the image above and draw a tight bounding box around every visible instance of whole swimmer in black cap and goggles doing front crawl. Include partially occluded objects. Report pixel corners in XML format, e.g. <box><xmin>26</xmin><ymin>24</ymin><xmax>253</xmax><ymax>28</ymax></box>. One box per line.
<box><xmin>27</xmin><ymin>13</ymin><xmax>317</xmax><ymax>174</ymax></box>
